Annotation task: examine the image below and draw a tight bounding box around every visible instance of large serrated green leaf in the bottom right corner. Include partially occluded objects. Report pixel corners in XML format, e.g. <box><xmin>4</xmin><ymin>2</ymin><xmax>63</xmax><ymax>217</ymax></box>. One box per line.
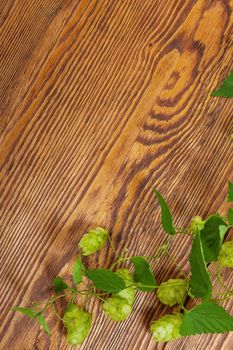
<box><xmin>180</xmin><ymin>302</ymin><xmax>233</xmax><ymax>336</ymax></box>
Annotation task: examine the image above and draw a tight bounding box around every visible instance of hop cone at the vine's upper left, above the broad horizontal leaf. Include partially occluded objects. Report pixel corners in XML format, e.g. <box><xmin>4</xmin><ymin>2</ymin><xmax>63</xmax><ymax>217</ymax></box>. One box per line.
<box><xmin>79</xmin><ymin>227</ymin><xmax>109</xmax><ymax>256</ymax></box>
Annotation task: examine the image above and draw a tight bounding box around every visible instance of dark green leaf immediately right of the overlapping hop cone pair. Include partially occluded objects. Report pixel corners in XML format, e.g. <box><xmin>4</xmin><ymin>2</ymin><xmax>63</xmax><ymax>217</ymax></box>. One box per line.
<box><xmin>130</xmin><ymin>256</ymin><xmax>157</xmax><ymax>292</ymax></box>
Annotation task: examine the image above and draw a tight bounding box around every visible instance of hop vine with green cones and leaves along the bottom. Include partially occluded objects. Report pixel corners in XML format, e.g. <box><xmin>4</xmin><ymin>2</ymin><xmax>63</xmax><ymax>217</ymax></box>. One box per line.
<box><xmin>12</xmin><ymin>182</ymin><xmax>233</xmax><ymax>345</ymax></box>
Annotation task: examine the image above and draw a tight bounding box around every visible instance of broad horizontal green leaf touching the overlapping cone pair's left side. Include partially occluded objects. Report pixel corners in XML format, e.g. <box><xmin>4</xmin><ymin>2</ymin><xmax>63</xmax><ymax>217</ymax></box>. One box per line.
<box><xmin>86</xmin><ymin>269</ymin><xmax>125</xmax><ymax>293</ymax></box>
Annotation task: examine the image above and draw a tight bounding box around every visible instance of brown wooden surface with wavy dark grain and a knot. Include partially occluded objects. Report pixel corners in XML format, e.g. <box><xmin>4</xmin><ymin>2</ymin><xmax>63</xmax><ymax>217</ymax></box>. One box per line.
<box><xmin>0</xmin><ymin>0</ymin><xmax>233</xmax><ymax>350</ymax></box>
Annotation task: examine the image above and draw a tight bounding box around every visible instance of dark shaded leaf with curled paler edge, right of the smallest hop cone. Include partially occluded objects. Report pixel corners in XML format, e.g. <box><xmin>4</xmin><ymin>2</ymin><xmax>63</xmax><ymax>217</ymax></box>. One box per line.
<box><xmin>200</xmin><ymin>215</ymin><xmax>227</xmax><ymax>263</ymax></box>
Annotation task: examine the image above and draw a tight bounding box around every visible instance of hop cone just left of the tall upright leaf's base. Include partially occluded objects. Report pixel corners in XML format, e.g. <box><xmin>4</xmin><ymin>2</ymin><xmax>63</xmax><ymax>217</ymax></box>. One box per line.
<box><xmin>157</xmin><ymin>278</ymin><xmax>188</xmax><ymax>306</ymax></box>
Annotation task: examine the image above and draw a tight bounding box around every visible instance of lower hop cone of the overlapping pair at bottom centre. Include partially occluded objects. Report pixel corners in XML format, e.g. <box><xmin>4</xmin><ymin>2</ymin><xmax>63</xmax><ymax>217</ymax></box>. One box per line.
<box><xmin>102</xmin><ymin>296</ymin><xmax>133</xmax><ymax>321</ymax></box>
